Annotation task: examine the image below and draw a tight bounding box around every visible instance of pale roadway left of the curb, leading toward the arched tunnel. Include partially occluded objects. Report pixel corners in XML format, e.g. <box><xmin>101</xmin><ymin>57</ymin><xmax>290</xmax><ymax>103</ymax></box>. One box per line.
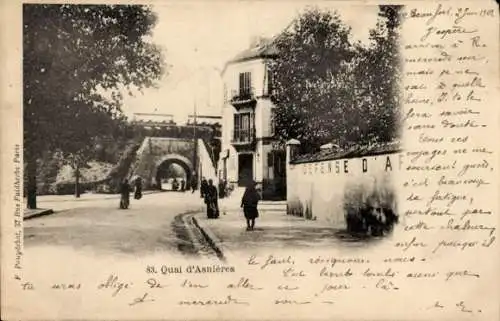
<box><xmin>24</xmin><ymin>192</ymin><xmax>213</xmax><ymax>255</ymax></box>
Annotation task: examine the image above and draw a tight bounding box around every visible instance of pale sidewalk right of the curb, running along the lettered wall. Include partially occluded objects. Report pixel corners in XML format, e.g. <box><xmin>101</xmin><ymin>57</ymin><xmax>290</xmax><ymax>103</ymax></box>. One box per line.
<box><xmin>194</xmin><ymin>210</ymin><xmax>363</xmax><ymax>255</ymax></box>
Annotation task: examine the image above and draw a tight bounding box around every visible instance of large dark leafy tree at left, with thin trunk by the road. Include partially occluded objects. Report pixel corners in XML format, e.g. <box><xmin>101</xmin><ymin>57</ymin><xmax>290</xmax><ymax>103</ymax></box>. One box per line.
<box><xmin>23</xmin><ymin>4</ymin><xmax>165</xmax><ymax>208</ymax></box>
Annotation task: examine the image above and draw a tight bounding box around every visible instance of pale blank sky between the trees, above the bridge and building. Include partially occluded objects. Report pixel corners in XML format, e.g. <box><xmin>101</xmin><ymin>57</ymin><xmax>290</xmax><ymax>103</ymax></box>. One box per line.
<box><xmin>123</xmin><ymin>1</ymin><xmax>378</xmax><ymax>122</ymax></box>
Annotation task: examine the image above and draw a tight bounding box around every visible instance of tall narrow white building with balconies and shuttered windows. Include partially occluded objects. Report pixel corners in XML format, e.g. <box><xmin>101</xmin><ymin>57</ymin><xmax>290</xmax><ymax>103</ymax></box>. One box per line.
<box><xmin>218</xmin><ymin>40</ymin><xmax>286</xmax><ymax>199</ymax></box>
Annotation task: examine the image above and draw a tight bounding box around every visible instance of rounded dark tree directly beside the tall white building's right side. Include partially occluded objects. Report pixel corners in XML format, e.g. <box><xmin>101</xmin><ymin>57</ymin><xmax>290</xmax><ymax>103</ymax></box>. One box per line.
<box><xmin>269</xmin><ymin>9</ymin><xmax>354</xmax><ymax>150</ymax></box>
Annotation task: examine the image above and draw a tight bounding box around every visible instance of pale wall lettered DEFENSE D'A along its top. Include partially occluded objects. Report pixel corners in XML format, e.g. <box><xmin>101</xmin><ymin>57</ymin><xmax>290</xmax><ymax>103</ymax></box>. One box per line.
<box><xmin>287</xmin><ymin>142</ymin><xmax>401</xmax><ymax>228</ymax></box>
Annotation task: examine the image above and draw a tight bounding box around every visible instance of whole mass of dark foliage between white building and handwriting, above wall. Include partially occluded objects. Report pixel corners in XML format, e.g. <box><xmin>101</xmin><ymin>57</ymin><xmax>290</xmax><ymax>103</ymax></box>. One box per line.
<box><xmin>269</xmin><ymin>6</ymin><xmax>400</xmax><ymax>152</ymax></box>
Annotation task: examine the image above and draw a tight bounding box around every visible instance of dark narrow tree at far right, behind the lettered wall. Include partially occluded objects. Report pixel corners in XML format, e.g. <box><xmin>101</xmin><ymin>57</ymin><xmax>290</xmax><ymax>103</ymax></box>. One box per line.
<box><xmin>354</xmin><ymin>5</ymin><xmax>402</xmax><ymax>142</ymax></box>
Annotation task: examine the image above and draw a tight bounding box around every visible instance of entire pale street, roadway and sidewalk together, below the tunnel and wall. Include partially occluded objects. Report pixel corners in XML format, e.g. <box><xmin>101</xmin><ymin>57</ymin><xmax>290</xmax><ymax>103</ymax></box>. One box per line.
<box><xmin>24</xmin><ymin>192</ymin><xmax>376</xmax><ymax>259</ymax></box>
